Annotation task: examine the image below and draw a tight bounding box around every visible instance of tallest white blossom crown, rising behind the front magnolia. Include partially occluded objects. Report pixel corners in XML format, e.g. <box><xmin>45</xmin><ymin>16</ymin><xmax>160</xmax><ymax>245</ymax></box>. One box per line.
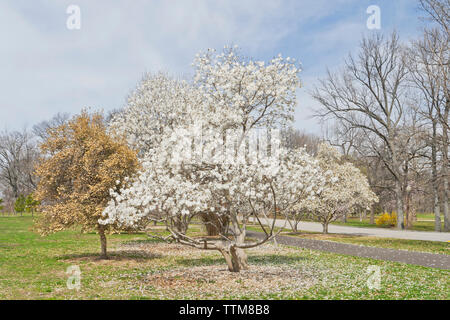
<box><xmin>194</xmin><ymin>47</ymin><xmax>300</xmax><ymax>129</ymax></box>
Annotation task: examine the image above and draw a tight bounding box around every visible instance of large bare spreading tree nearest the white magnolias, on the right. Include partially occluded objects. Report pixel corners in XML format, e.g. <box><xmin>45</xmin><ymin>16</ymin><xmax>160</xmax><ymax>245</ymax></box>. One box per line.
<box><xmin>312</xmin><ymin>32</ymin><xmax>420</xmax><ymax>228</ymax></box>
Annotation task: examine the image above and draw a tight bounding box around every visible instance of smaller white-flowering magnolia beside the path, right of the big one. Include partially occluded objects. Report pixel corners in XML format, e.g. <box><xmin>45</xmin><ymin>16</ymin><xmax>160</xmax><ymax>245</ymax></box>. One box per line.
<box><xmin>302</xmin><ymin>143</ymin><xmax>378</xmax><ymax>233</ymax></box>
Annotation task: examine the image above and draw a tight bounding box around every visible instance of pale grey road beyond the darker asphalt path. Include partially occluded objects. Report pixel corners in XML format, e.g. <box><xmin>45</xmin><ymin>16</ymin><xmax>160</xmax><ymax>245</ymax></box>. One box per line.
<box><xmin>251</xmin><ymin>219</ymin><xmax>450</xmax><ymax>242</ymax></box>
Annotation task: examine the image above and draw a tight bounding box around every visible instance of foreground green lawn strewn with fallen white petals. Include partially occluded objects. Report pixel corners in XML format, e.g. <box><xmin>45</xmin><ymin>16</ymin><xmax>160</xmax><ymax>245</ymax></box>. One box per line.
<box><xmin>0</xmin><ymin>216</ymin><xmax>450</xmax><ymax>299</ymax></box>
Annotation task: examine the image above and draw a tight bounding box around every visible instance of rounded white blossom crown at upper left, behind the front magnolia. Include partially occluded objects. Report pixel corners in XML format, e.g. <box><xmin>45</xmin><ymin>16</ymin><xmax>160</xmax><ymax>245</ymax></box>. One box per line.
<box><xmin>109</xmin><ymin>73</ymin><xmax>204</xmax><ymax>155</ymax></box>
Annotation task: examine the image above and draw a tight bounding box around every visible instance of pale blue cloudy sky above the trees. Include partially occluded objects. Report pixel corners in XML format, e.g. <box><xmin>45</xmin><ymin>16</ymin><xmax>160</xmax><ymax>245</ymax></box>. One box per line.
<box><xmin>0</xmin><ymin>0</ymin><xmax>421</xmax><ymax>134</ymax></box>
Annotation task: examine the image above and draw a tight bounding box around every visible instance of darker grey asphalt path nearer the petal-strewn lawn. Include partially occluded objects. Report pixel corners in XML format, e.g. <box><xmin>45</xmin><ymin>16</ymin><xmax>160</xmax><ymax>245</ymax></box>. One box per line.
<box><xmin>247</xmin><ymin>231</ymin><xmax>450</xmax><ymax>270</ymax></box>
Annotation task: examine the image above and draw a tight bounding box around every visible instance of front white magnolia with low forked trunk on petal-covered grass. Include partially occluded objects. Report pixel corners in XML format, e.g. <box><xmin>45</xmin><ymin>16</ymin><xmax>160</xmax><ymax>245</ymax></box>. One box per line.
<box><xmin>101</xmin><ymin>127</ymin><xmax>322</xmax><ymax>272</ymax></box>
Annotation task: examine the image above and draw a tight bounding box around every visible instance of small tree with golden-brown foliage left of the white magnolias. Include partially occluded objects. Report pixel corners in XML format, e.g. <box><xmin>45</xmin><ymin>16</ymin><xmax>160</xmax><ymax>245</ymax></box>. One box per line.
<box><xmin>35</xmin><ymin>111</ymin><xmax>138</xmax><ymax>258</ymax></box>
